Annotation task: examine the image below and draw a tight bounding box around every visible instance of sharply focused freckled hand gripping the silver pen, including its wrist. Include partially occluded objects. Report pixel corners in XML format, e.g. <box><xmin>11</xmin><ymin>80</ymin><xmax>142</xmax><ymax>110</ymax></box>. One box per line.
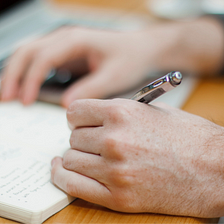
<box><xmin>52</xmin><ymin>99</ymin><xmax>224</xmax><ymax>217</ymax></box>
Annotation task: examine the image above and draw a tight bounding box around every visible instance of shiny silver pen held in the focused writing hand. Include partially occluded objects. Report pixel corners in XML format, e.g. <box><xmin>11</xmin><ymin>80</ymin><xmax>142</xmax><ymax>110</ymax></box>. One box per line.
<box><xmin>131</xmin><ymin>71</ymin><xmax>182</xmax><ymax>104</ymax></box>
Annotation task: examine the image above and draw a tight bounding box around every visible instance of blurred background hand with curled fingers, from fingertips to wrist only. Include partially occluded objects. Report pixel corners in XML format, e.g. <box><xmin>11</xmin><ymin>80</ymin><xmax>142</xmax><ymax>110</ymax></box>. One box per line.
<box><xmin>1</xmin><ymin>27</ymin><xmax>156</xmax><ymax>107</ymax></box>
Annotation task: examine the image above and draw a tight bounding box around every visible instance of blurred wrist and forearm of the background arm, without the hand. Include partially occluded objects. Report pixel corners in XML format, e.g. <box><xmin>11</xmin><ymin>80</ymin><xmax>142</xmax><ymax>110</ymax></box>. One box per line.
<box><xmin>138</xmin><ymin>17</ymin><xmax>224</xmax><ymax>74</ymax></box>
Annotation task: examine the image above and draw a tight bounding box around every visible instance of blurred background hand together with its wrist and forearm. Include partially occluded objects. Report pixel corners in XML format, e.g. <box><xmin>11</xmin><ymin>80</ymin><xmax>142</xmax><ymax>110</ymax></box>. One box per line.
<box><xmin>1</xmin><ymin>18</ymin><xmax>224</xmax><ymax>107</ymax></box>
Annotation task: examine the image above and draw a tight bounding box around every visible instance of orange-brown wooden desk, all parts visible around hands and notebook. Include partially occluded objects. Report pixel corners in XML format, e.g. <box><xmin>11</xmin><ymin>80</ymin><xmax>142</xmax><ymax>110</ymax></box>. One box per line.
<box><xmin>0</xmin><ymin>0</ymin><xmax>224</xmax><ymax>224</ymax></box>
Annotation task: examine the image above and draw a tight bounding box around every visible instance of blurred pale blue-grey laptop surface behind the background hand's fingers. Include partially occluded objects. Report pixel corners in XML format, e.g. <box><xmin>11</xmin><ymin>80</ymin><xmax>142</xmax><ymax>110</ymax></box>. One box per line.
<box><xmin>0</xmin><ymin>1</ymin><xmax>69</xmax><ymax>60</ymax></box>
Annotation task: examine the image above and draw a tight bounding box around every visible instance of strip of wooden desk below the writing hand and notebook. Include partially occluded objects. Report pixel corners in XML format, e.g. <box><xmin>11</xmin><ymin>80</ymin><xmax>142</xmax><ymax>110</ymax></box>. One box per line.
<box><xmin>0</xmin><ymin>199</ymin><xmax>218</xmax><ymax>224</ymax></box>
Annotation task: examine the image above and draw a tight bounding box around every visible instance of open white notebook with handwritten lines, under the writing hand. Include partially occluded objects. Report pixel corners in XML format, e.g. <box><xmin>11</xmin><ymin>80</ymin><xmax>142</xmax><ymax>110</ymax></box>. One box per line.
<box><xmin>0</xmin><ymin>102</ymin><xmax>74</xmax><ymax>224</ymax></box>
